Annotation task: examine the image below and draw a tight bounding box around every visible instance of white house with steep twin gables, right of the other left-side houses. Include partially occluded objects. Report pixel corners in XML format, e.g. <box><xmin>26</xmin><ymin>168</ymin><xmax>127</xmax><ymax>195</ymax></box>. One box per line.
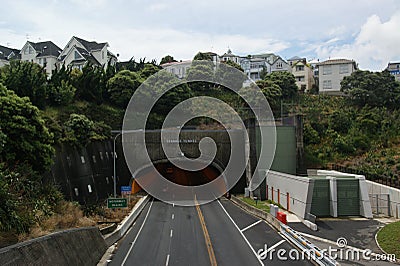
<box><xmin>58</xmin><ymin>36</ymin><xmax>117</xmax><ymax>69</ymax></box>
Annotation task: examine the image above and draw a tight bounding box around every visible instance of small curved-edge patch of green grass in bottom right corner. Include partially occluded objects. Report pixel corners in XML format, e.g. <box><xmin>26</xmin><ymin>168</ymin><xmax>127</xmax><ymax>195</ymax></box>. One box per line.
<box><xmin>377</xmin><ymin>221</ymin><xmax>400</xmax><ymax>258</ymax></box>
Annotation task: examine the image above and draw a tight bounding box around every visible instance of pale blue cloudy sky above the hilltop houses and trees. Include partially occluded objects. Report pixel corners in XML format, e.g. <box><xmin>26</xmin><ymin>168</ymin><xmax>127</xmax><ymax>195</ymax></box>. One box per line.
<box><xmin>0</xmin><ymin>0</ymin><xmax>400</xmax><ymax>71</ymax></box>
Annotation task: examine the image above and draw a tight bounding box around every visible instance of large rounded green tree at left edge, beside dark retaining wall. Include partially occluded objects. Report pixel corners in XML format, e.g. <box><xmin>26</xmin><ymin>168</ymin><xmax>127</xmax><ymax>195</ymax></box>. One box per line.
<box><xmin>0</xmin><ymin>84</ymin><xmax>54</xmax><ymax>172</ymax></box>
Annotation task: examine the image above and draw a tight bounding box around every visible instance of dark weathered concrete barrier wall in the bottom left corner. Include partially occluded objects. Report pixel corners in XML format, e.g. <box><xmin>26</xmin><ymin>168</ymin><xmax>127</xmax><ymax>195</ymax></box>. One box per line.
<box><xmin>0</xmin><ymin>227</ymin><xmax>107</xmax><ymax>266</ymax></box>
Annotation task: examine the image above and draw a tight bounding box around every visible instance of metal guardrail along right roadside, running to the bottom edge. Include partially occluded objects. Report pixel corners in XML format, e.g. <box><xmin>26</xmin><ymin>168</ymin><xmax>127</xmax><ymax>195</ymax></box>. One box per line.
<box><xmin>280</xmin><ymin>223</ymin><xmax>338</xmax><ymax>266</ymax></box>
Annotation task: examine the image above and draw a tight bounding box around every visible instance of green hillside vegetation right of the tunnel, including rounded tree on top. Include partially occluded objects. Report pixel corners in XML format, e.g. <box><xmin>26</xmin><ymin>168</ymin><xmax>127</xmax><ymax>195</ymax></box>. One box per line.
<box><xmin>302</xmin><ymin>71</ymin><xmax>400</xmax><ymax>178</ymax></box>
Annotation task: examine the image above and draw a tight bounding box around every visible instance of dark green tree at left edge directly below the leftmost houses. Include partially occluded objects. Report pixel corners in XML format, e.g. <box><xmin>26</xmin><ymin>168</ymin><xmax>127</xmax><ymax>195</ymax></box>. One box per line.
<box><xmin>1</xmin><ymin>61</ymin><xmax>48</xmax><ymax>108</ymax></box>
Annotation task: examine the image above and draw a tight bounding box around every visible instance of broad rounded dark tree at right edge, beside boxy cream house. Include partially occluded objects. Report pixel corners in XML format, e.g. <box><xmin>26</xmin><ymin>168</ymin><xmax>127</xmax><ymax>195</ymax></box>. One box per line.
<box><xmin>340</xmin><ymin>70</ymin><xmax>400</xmax><ymax>109</ymax></box>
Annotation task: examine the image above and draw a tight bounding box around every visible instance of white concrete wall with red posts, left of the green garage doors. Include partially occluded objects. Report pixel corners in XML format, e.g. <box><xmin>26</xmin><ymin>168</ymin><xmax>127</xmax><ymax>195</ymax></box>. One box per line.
<box><xmin>266</xmin><ymin>171</ymin><xmax>314</xmax><ymax>219</ymax></box>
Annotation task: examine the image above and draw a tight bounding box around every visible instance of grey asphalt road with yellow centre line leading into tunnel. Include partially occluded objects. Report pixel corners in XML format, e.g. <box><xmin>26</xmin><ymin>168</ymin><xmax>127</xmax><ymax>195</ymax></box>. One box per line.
<box><xmin>110</xmin><ymin>167</ymin><xmax>312</xmax><ymax>265</ymax></box>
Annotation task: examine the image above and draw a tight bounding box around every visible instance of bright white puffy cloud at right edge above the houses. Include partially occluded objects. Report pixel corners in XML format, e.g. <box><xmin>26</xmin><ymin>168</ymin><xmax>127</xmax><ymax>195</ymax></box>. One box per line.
<box><xmin>316</xmin><ymin>12</ymin><xmax>400</xmax><ymax>70</ymax></box>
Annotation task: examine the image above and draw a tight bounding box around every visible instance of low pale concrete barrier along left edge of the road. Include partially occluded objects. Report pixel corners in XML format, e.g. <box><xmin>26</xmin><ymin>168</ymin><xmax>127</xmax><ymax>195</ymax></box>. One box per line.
<box><xmin>104</xmin><ymin>195</ymin><xmax>150</xmax><ymax>247</ymax></box>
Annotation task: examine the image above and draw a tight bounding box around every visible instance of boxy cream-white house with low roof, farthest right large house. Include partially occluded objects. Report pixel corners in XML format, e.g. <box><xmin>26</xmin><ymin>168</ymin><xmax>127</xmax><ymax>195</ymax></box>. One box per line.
<box><xmin>317</xmin><ymin>59</ymin><xmax>357</xmax><ymax>95</ymax></box>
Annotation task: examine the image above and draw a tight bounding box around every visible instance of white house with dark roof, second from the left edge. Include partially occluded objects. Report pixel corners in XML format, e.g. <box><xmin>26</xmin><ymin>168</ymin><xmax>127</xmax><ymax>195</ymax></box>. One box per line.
<box><xmin>20</xmin><ymin>41</ymin><xmax>61</xmax><ymax>77</ymax></box>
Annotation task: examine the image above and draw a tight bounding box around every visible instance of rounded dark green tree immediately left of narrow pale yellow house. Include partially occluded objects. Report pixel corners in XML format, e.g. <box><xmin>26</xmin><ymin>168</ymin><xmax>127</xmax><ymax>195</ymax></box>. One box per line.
<box><xmin>264</xmin><ymin>71</ymin><xmax>298</xmax><ymax>100</ymax></box>
